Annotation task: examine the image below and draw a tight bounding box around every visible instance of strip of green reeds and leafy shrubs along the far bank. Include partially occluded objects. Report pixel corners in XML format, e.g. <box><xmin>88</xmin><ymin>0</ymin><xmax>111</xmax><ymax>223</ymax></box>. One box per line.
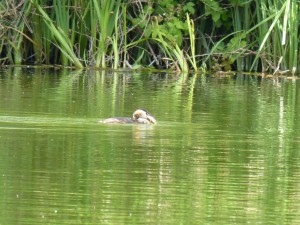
<box><xmin>0</xmin><ymin>0</ymin><xmax>300</xmax><ymax>76</ymax></box>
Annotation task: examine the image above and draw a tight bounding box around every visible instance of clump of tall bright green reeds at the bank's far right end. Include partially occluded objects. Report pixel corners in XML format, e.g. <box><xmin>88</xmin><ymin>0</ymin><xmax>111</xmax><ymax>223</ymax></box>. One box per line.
<box><xmin>251</xmin><ymin>0</ymin><xmax>300</xmax><ymax>75</ymax></box>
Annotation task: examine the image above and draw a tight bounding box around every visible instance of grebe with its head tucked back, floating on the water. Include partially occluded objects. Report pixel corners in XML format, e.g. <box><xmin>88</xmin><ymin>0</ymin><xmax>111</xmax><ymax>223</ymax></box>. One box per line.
<box><xmin>99</xmin><ymin>109</ymin><xmax>157</xmax><ymax>124</ymax></box>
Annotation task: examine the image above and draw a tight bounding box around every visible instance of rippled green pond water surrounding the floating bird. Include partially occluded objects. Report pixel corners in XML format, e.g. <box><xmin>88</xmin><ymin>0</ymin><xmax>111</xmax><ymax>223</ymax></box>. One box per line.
<box><xmin>0</xmin><ymin>68</ymin><xmax>300</xmax><ymax>225</ymax></box>
